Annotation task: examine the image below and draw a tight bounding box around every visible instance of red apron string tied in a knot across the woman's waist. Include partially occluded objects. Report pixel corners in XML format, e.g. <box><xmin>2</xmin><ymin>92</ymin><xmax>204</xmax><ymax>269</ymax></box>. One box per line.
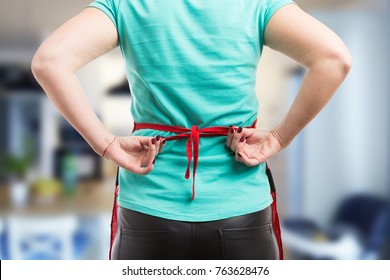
<box><xmin>133</xmin><ymin>120</ymin><xmax>257</xmax><ymax>200</ymax></box>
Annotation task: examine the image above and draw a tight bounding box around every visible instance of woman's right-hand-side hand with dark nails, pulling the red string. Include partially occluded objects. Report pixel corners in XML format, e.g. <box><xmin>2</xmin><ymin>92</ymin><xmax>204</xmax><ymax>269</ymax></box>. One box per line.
<box><xmin>226</xmin><ymin>127</ymin><xmax>284</xmax><ymax>166</ymax></box>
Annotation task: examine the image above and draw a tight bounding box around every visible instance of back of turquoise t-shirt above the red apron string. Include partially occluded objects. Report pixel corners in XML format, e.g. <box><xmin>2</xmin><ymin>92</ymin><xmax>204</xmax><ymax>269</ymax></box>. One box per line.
<box><xmin>92</xmin><ymin>0</ymin><xmax>291</xmax><ymax>127</ymax></box>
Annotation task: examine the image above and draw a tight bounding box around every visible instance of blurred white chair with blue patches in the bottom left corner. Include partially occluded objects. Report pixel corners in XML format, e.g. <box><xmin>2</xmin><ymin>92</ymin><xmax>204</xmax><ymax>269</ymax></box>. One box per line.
<box><xmin>7</xmin><ymin>215</ymin><xmax>77</xmax><ymax>260</ymax></box>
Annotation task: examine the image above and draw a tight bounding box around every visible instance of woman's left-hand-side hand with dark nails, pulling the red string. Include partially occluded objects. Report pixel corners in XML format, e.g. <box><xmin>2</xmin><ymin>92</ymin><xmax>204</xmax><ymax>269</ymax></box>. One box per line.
<box><xmin>103</xmin><ymin>136</ymin><xmax>166</xmax><ymax>175</ymax></box>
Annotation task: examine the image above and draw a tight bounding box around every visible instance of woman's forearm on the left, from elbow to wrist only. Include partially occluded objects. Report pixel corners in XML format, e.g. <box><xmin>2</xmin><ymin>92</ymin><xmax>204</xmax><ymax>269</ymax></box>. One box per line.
<box><xmin>32</xmin><ymin>60</ymin><xmax>114</xmax><ymax>155</ymax></box>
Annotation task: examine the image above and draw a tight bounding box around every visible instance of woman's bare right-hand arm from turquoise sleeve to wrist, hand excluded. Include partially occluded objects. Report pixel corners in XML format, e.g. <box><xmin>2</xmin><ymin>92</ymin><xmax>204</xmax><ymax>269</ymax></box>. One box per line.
<box><xmin>264</xmin><ymin>5</ymin><xmax>351</xmax><ymax>146</ymax></box>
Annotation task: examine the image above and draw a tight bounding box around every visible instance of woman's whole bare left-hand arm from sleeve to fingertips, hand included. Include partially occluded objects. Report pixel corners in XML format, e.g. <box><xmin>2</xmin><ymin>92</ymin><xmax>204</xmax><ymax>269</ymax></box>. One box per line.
<box><xmin>32</xmin><ymin>8</ymin><xmax>164</xmax><ymax>174</ymax></box>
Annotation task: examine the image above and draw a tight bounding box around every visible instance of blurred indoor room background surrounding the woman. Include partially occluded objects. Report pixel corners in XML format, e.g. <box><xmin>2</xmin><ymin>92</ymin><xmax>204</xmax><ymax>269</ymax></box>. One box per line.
<box><xmin>0</xmin><ymin>0</ymin><xmax>390</xmax><ymax>259</ymax></box>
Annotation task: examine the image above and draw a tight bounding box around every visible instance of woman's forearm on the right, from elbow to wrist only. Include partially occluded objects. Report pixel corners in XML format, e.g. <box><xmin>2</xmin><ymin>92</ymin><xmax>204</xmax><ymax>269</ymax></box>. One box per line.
<box><xmin>275</xmin><ymin>58</ymin><xmax>350</xmax><ymax>146</ymax></box>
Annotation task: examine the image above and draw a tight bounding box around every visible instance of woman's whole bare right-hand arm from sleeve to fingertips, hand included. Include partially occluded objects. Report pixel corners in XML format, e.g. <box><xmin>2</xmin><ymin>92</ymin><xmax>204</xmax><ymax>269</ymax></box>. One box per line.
<box><xmin>226</xmin><ymin>5</ymin><xmax>351</xmax><ymax>166</ymax></box>
